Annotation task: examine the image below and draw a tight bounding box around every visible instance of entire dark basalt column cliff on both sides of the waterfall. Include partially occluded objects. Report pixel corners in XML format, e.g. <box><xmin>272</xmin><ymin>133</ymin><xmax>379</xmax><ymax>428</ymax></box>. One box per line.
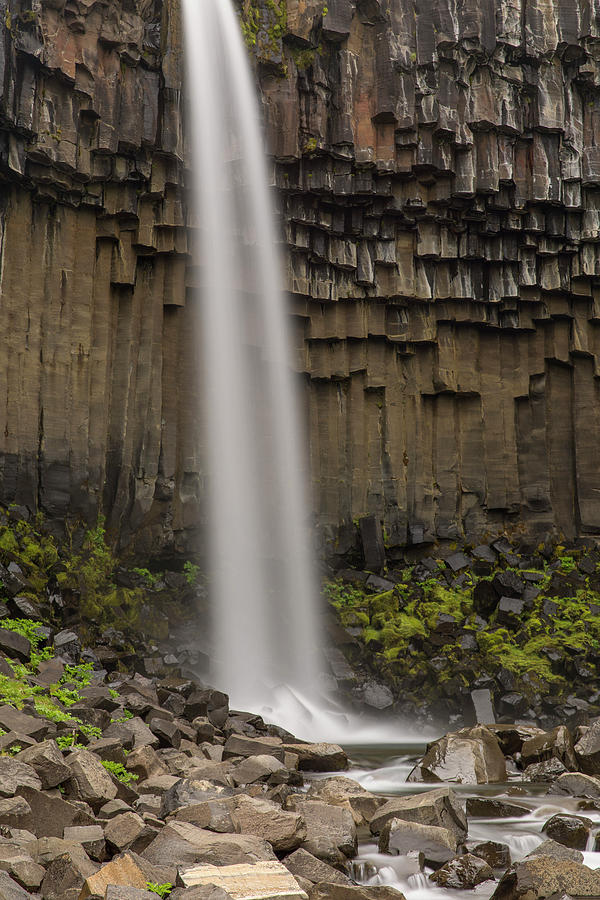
<box><xmin>0</xmin><ymin>0</ymin><xmax>600</xmax><ymax>549</ymax></box>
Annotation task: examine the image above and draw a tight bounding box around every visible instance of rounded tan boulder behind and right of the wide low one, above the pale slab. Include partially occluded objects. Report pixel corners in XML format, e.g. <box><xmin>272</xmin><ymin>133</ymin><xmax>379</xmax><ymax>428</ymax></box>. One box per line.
<box><xmin>231</xmin><ymin>794</ymin><xmax>308</xmax><ymax>853</ymax></box>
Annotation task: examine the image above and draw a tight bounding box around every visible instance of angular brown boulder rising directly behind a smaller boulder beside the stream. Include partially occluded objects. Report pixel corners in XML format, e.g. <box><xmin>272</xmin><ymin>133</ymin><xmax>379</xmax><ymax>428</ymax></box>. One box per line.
<box><xmin>371</xmin><ymin>787</ymin><xmax>467</xmax><ymax>841</ymax></box>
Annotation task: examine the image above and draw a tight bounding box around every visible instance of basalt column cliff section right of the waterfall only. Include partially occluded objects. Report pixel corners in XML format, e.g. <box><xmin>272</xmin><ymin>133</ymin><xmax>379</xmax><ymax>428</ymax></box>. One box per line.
<box><xmin>258</xmin><ymin>0</ymin><xmax>600</xmax><ymax>544</ymax></box>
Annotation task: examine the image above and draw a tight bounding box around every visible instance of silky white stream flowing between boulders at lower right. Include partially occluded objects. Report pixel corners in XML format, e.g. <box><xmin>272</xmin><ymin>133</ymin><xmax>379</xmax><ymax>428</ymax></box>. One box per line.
<box><xmin>345</xmin><ymin>741</ymin><xmax>600</xmax><ymax>900</ymax></box>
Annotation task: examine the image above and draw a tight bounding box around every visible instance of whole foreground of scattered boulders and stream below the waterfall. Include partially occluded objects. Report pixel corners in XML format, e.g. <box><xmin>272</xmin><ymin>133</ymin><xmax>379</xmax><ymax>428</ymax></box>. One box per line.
<box><xmin>0</xmin><ymin>619</ymin><xmax>600</xmax><ymax>900</ymax></box>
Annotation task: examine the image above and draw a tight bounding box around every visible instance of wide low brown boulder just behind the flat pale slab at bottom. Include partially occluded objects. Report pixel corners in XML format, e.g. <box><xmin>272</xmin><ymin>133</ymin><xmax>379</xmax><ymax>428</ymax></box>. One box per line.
<box><xmin>141</xmin><ymin>821</ymin><xmax>275</xmax><ymax>866</ymax></box>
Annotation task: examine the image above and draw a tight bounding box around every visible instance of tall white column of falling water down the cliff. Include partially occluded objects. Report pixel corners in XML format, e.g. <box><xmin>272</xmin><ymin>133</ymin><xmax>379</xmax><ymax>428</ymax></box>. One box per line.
<box><xmin>183</xmin><ymin>0</ymin><xmax>317</xmax><ymax>711</ymax></box>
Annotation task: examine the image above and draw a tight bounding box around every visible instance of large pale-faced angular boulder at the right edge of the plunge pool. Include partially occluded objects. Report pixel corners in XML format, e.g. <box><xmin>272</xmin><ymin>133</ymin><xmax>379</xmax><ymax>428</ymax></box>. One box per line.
<box><xmin>408</xmin><ymin>725</ymin><xmax>506</xmax><ymax>784</ymax></box>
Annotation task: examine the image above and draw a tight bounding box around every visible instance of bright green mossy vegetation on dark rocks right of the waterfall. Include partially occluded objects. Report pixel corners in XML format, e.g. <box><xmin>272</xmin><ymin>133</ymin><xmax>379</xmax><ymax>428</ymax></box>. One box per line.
<box><xmin>324</xmin><ymin>546</ymin><xmax>600</xmax><ymax>712</ymax></box>
